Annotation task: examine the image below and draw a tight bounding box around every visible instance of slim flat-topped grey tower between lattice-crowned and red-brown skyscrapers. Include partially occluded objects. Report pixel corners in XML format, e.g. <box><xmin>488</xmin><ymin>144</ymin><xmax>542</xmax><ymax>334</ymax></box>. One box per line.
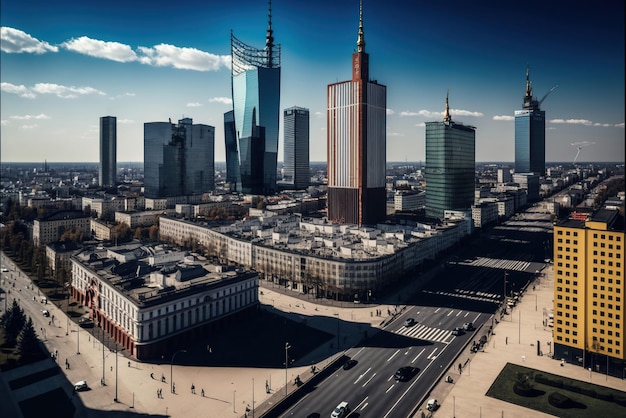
<box><xmin>283</xmin><ymin>106</ymin><xmax>311</xmax><ymax>189</ymax></box>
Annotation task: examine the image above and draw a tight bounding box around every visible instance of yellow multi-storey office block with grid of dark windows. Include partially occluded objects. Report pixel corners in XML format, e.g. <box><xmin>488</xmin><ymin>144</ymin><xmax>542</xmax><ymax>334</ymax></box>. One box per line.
<box><xmin>554</xmin><ymin>209</ymin><xmax>626</xmax><ymax>378</ymax></box>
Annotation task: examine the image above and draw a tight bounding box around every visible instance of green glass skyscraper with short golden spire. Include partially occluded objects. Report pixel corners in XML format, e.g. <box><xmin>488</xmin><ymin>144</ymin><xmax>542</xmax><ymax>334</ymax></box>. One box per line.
<box><xmin>424</xmin><ymin>96</ymin><xmax>476</xmax><ymax>219</ymax></box>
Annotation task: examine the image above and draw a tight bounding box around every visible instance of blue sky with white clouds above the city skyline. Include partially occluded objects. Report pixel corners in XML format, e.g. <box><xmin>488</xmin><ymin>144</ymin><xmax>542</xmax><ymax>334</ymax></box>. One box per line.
<box><xmin>0</xmin><ymin>0</ymin><xmax>625</xmax><ymax>162</ymax></box>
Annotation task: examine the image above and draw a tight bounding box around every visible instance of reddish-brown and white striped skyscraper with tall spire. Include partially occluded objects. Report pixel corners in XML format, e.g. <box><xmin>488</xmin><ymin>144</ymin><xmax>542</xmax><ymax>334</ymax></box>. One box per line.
<box><xmin>327</xmin><ymin>4</ymin><xmax>387</xmax><ymax>225</ymax></box>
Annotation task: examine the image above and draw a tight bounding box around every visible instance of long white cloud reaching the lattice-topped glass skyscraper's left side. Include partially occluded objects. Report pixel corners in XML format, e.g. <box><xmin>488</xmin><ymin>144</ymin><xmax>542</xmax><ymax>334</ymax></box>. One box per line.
<box><xmin>137</xmin><ymin>44</ymin><xmax>230</xmax><ymax>71</ymax></box>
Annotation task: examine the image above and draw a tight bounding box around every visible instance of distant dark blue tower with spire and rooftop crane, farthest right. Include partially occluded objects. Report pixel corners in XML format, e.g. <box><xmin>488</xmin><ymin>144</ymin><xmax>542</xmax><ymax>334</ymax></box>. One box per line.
<box><xmin>515</xmin><ymin>68</ymin><xmax>554</xmax><ymax>176</ymax></box>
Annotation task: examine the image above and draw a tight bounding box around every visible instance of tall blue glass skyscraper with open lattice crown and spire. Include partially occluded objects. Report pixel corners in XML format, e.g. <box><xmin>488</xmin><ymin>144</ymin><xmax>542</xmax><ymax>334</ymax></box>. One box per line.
<box><xmin>226</xmin><ymin>2</ymin><xmax>280</xmax><ymax>195</ymax></box>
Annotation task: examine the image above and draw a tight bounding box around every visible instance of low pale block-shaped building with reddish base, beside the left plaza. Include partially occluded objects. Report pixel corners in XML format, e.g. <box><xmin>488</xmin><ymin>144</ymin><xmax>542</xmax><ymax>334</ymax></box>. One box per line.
<box><xmin>71</xmin><ymin>247</ymin><xmax>259</xmax><ymax>360</ymax></box>
